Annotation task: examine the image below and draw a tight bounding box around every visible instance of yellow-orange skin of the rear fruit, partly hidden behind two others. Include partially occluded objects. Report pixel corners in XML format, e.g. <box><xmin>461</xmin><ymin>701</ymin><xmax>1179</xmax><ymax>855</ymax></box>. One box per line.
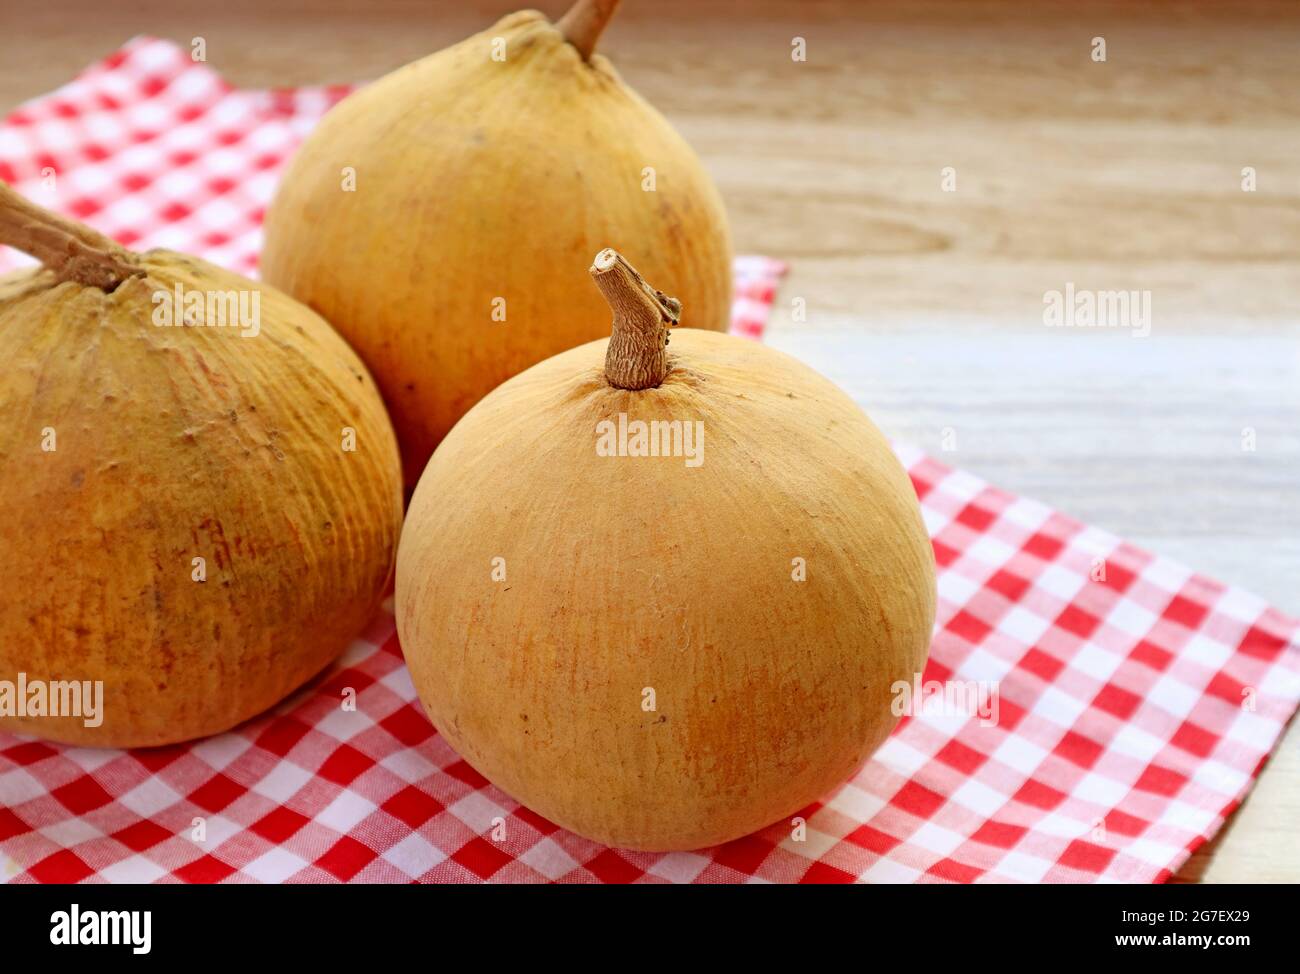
<box><xmin>261</xmin><ymin>10</ymin><xmax>732</xmax><ymax>486</ymax></box>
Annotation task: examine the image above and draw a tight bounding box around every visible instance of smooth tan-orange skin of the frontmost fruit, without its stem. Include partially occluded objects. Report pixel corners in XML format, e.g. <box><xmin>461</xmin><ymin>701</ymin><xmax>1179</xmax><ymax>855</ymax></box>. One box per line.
<box><xmin>397</xmin><ymin>329</ymin><xmax>935</xmax><ymax>852</ymax></box>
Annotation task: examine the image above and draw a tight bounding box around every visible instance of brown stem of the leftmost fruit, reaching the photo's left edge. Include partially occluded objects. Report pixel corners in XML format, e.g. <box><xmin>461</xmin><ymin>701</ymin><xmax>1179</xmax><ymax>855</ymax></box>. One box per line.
<box><xmin>0</xmin><ymin>182</ymin><xmax>144</xmax><ymax>291</ymax></box>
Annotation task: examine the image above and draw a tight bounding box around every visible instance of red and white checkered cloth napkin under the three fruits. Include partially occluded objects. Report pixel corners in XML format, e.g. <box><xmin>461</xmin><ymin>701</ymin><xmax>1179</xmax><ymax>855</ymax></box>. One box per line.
<box><xmin>0</xmin><ymin>39</ymin><xmax>1300</xmax><ymax>882</ymax></box>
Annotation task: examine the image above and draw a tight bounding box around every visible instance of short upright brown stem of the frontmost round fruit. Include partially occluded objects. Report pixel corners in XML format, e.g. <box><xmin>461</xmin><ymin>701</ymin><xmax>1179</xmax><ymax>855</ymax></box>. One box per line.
<box><xmin>592</xmin><ymin>248</ymin><xmax>681</xmax><ymax>390</ymax></box>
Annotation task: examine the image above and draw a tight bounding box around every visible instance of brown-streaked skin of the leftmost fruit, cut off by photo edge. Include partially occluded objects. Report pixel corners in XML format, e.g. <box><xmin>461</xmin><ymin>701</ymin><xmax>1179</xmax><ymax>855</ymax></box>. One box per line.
<box><xmin>0</xmin><ymin>251</ymin><xmax>402</xmax><ymax>746</ymax></box>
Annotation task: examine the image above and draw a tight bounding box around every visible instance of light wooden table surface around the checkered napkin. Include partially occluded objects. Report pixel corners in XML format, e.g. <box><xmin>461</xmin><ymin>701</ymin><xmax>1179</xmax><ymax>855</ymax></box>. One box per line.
<box><xmin>0</xmin><ymin>0</ymin><xmax>1300</xmax><ymax>882</ymax></box>
